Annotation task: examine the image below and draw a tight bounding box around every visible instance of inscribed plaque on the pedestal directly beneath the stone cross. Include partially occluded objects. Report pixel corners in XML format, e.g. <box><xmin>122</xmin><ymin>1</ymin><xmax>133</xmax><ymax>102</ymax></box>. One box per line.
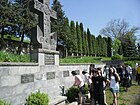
<box><xmin>45</xmin><ymin>54</ymin><xmax>55</xmax><ymax>65</ymax></box>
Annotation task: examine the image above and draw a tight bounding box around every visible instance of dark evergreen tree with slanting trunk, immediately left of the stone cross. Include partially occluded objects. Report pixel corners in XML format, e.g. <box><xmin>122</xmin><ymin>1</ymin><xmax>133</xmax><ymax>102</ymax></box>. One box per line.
<box><xmin>16</xmin><ymin>0</ymin><xmax>37</xmax><ymax>54</ymax></box>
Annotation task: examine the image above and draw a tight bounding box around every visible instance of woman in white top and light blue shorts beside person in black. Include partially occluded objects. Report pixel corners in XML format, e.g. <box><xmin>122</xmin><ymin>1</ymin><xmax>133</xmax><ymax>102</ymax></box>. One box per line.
<box><xmin>109</xmin><ymin>67</ymin><xmax>120</xmax><ymax>105</ymax></box>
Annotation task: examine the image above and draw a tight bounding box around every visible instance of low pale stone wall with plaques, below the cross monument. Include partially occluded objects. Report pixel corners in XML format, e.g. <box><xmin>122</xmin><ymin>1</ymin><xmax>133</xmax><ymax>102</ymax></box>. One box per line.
<box><xmin>0</xmin><ymin>63</ymin><xmax>105</xmax><ymax>105</ymax></box>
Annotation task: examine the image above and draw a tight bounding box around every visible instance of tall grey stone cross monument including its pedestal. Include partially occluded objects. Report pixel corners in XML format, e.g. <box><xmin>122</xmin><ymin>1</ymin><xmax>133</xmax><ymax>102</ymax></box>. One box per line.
<box><xmin>31</xmin><ymin>0</ymin><xmax>59</xmax><ymax>65</ymax></box>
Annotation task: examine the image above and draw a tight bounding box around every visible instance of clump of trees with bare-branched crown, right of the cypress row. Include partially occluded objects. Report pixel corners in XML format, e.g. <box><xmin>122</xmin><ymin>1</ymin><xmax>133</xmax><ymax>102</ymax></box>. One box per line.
<box><xmin>100</xmin><ymin>19</ymin><xmax>140</xmax><ymax>56</ymax></box>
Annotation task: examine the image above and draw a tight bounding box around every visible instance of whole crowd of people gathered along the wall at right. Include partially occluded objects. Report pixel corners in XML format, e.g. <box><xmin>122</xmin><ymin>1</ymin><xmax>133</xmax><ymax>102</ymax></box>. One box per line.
<box><xmin>71</xmin><ymin>63</ymin><xmax>140</xmax><ymax>105</ymax></box>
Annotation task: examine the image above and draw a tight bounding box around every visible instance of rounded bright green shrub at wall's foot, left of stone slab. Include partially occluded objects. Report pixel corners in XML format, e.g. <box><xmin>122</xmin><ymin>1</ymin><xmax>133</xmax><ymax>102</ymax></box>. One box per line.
<box><xmin>25</xmin><ymin>91</ymin><xmax>49</xmax><ymax>105</ymax></box>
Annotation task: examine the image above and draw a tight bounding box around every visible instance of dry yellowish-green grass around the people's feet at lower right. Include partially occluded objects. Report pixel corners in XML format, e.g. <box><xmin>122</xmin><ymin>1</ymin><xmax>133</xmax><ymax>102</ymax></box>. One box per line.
<box><xmin>106</xmin><ymin>81</ymin><xmax>140</xmax><ymax>105</ymax></box>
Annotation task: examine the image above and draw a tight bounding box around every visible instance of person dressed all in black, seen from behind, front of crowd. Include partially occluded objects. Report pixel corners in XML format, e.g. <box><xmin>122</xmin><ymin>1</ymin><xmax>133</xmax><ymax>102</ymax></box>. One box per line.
<box><xmin>92</xmin><ymin>69</ymin><xmax>109</xmax><ymax>105</ymax></box>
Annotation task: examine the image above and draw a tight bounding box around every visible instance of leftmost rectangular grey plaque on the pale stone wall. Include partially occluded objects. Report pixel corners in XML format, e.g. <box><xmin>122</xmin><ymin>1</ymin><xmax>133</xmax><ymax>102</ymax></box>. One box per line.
<box><xmin>21</xmin><ymin>74</ymin><xmax>34</xmax><ymax>83</ymax></box>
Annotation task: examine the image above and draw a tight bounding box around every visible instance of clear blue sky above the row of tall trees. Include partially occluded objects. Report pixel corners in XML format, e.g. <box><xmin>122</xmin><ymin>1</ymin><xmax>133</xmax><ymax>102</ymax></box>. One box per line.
<box><xmin>50</xmin><ymin>0</ymin><xmax>140</xmax><ymax>39</ymax></box>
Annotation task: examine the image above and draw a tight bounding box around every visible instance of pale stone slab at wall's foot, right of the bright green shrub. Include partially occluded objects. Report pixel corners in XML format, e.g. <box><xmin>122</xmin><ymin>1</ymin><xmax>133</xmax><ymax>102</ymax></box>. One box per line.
<box><xmin>49</xmin><ymin>96</ymin><xmax>67</xmax><ymax>105</ymax></box>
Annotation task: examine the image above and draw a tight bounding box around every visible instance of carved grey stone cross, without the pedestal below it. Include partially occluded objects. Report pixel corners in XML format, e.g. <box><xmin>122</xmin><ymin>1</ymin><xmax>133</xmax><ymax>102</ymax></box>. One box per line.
<box><xmin>34</xmin><ymin>0</ymin><xmax>57</xmax><ymax>50</ymax></box>
